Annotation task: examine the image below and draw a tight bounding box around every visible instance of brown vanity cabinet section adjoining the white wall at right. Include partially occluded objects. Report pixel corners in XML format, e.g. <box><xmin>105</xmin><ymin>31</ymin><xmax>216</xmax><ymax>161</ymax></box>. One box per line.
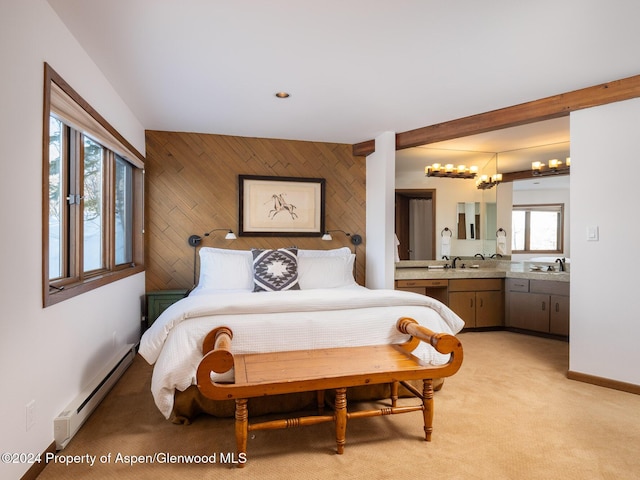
<box><xmin>507</xmin><ymin>278</ymin><xmax>569</xmax><ymax>336</ymax></box>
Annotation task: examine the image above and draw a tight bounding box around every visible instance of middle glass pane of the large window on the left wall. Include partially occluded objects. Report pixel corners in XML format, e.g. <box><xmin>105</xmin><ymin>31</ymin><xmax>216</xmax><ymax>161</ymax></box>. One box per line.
<box><xmin>83</xmin><ymin>137</ymin><xmax>104</xmax><ymax>272</ymax></box>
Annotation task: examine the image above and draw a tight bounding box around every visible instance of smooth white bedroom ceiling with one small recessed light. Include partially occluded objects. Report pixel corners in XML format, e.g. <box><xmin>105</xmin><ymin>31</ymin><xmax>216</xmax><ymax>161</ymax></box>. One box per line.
<box><xmin>48</xmin><ymin>0</ymin><xmax>640</xmax><ymax>151</ymax></box>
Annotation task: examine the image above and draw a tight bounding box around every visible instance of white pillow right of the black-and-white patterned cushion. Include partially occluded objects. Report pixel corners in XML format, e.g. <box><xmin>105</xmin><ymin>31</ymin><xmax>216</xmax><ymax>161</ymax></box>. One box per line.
<box><xmin>298</xmin><ymin>255</ymin><xmax>356</xmax><ymax>290</ymax></box>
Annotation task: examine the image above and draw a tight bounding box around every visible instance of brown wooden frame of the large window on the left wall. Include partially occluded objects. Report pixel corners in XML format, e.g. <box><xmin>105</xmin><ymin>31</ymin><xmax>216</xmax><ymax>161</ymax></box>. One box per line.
<box><xmin>42</xmin><ymin>63</ymin><xmax>144</xmax><ymax>307</ymax></box>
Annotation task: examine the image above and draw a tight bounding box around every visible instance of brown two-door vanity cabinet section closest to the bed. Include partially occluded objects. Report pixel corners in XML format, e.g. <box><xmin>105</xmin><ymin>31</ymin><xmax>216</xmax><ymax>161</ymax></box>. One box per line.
<box><xmin>448</xmin><ymin>278</ymin><xmax>504</xmax><ymax>328</ymax></box>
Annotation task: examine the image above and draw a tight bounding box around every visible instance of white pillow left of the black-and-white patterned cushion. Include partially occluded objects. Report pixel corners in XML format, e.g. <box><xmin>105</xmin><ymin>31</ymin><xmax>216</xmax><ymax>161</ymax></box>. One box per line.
<box><xmin>198</xmin><ymin>247</ymin><xmax>253</xmax><ymax>290</ymax></box>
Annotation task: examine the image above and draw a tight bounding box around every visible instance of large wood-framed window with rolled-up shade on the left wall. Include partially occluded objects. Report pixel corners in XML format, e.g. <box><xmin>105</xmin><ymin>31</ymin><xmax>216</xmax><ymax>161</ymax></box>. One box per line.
<box><xmin>43</xmin><ymin>65</ymin><xmax>144</xmax><ymax>307</ymax></box>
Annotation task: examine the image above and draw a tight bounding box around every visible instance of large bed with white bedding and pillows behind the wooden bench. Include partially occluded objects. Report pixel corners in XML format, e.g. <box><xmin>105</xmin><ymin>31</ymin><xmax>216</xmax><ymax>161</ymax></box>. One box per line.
<box><xmin>139</xmin><ymin>247</ymin><xmax>464</xmax><ymax>423</ymax></box>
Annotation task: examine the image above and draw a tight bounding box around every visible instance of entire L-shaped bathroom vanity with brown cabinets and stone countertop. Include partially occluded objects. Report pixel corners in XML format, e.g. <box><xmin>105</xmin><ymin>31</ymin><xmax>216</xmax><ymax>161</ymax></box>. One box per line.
<box><xmin>395</xmin><ymin>259</ymin><xmax>570</xmax><ymax>337</ymax></box>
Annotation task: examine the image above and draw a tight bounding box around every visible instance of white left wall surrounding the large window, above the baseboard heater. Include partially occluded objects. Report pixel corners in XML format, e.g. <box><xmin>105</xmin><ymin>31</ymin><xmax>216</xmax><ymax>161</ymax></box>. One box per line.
<box><xmin>0</xmin><ymin>0</ymin><xmax>145</xmax><ymax>478</ymax></box>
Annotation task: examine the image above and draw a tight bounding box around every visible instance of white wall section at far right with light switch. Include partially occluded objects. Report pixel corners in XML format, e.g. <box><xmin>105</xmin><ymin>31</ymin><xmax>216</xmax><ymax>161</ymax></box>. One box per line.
<box><xmin>570</xmin><ymin>99</ymin><xmax>640</xmax><ymax>385</ymax></box>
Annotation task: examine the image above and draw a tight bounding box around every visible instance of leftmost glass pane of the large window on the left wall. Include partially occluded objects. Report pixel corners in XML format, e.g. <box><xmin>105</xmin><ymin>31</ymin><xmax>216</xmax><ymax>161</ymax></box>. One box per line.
<box><xmin>49</xmin><ymin>117</ymin><xmax>66</xmax><ymax>279</ymax></box>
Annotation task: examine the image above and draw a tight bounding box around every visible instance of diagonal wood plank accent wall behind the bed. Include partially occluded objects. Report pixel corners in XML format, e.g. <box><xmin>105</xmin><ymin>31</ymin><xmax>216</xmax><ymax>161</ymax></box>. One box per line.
<box><xmin>145</xmin><ymin>131</ymin><xmax>366</xmax><ymax>291</ymax></box>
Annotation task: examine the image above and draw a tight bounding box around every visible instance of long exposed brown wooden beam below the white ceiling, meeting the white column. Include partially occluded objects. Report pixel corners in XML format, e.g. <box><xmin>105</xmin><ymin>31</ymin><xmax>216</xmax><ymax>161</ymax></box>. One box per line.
<box><xmin>353</xmin><ymin>75</ymin><xmax>640</xmax><ymax>156</ymax></box>
